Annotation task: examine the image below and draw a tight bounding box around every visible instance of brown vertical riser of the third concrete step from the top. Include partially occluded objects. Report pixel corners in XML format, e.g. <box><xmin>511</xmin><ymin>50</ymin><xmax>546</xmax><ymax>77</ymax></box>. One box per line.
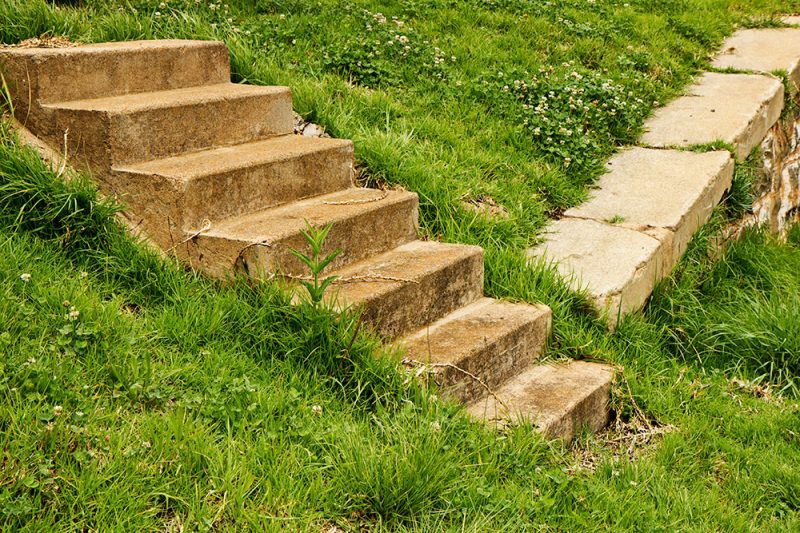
<box><xmin>110</xmin><ymin>139</ymin><xmax>353</xmax><ymax>246</ymax></box>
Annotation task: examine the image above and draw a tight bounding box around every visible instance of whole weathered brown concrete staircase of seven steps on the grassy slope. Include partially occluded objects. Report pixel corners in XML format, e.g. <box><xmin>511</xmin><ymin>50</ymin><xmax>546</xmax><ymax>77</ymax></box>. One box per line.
<box><xmin>0</xmin><ymin>41</ymin><xmax>612</xmax><ymax>438</ymax></box>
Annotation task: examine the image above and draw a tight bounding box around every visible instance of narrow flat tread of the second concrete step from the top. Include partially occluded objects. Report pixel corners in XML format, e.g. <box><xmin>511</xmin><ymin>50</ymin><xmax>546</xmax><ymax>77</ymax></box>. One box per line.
<box><xmin>43</xmin><ymin>83</ymin><xmax>290</xmax><ymax>114</ymax></box>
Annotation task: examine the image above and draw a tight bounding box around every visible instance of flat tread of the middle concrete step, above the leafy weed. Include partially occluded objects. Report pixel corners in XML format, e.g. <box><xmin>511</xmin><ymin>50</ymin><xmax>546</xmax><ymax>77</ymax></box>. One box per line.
<box><xmin>204</xmin><ymin>187</ymin><xmax>417</xmax><ymax>243</ymax></box>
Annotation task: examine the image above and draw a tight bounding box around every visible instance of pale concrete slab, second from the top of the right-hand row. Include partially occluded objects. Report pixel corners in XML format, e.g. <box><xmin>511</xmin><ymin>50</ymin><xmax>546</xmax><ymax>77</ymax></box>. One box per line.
<box><xmin>640</xmin><ymin>72</ymin><xmax>783</xmax><ymax>161</ymax></box>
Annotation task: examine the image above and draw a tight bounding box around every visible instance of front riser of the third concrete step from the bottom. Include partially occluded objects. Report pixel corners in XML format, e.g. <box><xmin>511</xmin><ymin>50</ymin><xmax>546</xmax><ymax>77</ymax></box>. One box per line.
<box><xmin>339</xmin><ymin>248</ymin><xmax>483</xmax><ymax>340</ymax></box>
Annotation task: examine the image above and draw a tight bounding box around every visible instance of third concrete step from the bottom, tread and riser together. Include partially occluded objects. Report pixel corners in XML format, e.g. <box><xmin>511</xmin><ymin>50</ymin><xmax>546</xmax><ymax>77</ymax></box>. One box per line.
<box><xmin>332</xmin><ymin>240</ymin><xmax>483</xmax><ymax>340</ymax></box>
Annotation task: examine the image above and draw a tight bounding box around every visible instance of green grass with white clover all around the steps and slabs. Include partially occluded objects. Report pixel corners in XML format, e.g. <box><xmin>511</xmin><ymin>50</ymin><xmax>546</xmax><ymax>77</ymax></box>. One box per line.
<box><xmin>0</xmin><ymin>0</ymin><xmax>800</xmax><ymax>531</ymax></box>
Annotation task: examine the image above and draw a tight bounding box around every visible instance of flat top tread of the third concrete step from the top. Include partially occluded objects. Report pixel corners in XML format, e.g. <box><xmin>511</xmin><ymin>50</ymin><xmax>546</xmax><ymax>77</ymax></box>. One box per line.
<box><xmin>115</xmin><ymin>135</ymin><xmax>353</xmax><ymax>181</ymax></box>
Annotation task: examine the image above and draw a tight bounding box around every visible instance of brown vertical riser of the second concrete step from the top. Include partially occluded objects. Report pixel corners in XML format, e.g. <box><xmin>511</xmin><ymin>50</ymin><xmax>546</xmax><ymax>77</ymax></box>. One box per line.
<box><xmin>42</xmin><ymin>91</ymin><xmax>293</xmax><ymax>172</ymax></box>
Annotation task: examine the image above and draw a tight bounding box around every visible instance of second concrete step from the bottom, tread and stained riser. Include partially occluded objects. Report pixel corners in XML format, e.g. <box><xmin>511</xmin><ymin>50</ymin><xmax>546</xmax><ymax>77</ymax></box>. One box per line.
<box><xmin>396</xmin><ymin>298</ymin><xmax>552</xmax><ymax>402</ymax></box>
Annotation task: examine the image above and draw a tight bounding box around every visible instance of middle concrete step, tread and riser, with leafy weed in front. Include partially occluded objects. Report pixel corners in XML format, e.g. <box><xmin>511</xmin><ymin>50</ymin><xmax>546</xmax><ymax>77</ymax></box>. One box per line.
<box><xmin>182</xmin><ymin>188</ymin><xmax>418</xmax><ymax>277</ymax></box>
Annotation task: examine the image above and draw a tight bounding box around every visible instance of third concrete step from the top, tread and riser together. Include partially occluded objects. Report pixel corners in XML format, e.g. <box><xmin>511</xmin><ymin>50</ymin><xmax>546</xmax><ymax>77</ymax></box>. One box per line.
<box><xmin>111</xmin><ymin>135</ymin><xmax>353</xmax><ymax>247</ymax></box>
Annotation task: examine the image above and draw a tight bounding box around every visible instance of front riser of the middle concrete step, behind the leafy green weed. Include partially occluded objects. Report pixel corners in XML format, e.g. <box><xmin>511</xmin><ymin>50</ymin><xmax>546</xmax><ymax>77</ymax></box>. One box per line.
<box><xmin>184</xmin><ymin>197</ymin><xmax>418</xmax><ymax>277</ymax></box>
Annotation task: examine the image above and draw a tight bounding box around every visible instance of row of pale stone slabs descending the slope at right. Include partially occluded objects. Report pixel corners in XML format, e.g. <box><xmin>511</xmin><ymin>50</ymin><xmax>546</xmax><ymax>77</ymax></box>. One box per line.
<box><xmin>529</xmin><ymin>17</ymin><xmax>800</xmax><ymax>328</ymax></box>
